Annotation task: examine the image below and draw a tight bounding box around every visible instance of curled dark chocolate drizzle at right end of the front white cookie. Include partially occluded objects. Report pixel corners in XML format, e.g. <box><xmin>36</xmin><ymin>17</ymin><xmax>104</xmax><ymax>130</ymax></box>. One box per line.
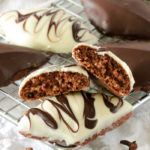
<box><xmin>102</xmin><ymin>94</ymin><xmax>123</xmax><ymax>113</ymax></box>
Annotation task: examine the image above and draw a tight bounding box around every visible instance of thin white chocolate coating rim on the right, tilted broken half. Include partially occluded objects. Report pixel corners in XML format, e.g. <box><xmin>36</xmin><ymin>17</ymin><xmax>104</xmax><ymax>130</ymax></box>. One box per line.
<box><xmin>72</xmin><ymin>43</ymin><xmax>135</xmax><ymax>95</ymax></box>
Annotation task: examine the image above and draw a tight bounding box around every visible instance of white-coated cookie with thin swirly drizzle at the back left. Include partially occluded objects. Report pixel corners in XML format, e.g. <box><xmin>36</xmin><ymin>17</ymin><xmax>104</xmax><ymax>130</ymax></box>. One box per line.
<box><xmin>0</xmin><ymin>7</ymin><xmax>98</xmax><ymax>53</ymax></box>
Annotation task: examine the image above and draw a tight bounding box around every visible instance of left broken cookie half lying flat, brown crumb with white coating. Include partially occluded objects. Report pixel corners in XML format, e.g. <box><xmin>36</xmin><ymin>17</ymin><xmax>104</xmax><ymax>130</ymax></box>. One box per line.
<box><xmin>19</xmin><ymin>65</ymin><xmax>90</xmax><ymax>100</ymax></box>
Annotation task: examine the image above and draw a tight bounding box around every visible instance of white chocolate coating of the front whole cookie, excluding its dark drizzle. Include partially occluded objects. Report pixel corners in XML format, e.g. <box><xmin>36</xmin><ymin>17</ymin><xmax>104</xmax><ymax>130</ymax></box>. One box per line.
<box><xmin>18</xmin><ymin>92</ymin><xmax>132</xmax><ymax>145</ymax></box>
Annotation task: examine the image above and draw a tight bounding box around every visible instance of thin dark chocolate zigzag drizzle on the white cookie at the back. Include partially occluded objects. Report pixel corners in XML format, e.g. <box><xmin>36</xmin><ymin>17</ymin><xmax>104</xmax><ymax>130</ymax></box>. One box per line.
<box><xmin>4</xmin><ymin>9</ymin><xmax>90</xmax><ymax>42</ymax></box>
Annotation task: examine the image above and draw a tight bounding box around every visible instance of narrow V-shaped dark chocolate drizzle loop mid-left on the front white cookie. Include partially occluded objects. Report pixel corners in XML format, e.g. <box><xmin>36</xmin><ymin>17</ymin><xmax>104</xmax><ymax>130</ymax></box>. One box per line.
<box><xmin>42</xmin><ymin>95</ymin><xmax>79</xmax><ymax>133</ymax></box>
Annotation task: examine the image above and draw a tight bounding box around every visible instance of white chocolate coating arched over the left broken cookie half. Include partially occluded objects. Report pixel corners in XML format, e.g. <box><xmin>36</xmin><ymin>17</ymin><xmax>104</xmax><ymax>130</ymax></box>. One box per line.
<box><xmin>19</xmin><ymin>65</ymin><xmax>89</xmax><ymax>93</ymax></box>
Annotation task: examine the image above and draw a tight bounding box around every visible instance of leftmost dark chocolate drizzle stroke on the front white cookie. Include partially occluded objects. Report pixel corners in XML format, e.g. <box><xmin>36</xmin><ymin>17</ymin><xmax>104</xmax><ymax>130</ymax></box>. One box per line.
<box><xmin>26</xmin><ymin>108</ymin><xmax>58</xmax><ymax>129</ymax></box>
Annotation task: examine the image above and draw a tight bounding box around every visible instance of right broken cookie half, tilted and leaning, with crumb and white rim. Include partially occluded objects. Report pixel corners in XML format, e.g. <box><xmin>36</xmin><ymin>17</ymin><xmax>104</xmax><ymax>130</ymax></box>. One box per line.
<box><xmin>73</xmin><ymin>44</ymin><xmax>134</xmax><ymax>97</ymax></box>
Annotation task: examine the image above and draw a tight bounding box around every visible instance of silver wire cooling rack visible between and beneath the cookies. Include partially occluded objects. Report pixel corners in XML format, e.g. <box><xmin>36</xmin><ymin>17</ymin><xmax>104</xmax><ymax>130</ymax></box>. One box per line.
<box><xmin>0</xmin><ymin>0</ymin><xmax>150</xmax><ymax>125</ymax></box>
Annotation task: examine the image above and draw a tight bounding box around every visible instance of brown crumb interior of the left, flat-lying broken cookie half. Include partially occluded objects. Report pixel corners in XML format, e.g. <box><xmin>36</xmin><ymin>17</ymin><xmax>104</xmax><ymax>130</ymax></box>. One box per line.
<box><xmin>20</xmin><ymin>71</ymin><xmax>89</xmax><ymax>100</ymax></box>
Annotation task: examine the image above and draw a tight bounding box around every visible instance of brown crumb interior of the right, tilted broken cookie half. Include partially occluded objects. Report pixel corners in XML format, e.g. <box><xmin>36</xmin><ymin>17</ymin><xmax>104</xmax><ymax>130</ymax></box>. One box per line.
<box><xmin>74</xmin><ymin>46</ymin><xmax>130</xmax><ymax>96</ymax></box>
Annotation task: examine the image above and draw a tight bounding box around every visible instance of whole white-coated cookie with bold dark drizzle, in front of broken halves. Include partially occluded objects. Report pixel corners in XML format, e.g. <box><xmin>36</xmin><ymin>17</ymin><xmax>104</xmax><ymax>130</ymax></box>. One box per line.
<box><xmin>18</xmin><ymin>92</ymin><xmax>132</xmax><ymax>146</ymax></box>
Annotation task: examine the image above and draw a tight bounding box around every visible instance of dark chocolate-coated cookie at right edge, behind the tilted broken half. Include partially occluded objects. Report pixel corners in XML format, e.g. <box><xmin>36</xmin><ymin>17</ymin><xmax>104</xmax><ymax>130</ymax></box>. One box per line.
<box><xmin>101</xmin><ymin>41</ymin><xmax>150</xmax><ymax>91</ymax></box>
